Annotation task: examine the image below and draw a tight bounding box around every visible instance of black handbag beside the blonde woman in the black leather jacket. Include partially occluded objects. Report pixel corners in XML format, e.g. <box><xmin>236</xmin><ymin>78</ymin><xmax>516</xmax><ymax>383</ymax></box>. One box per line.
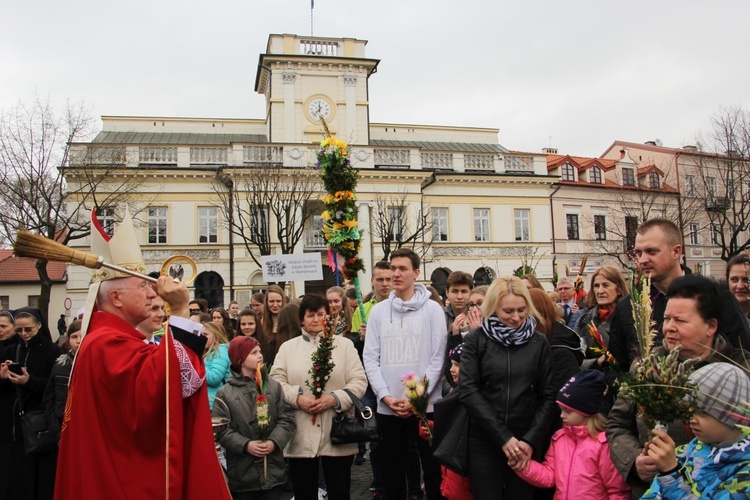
<box><xmin>432</xmin><ymin>389</ymin><xmax>469</xmax><ymax>476</ymax></box>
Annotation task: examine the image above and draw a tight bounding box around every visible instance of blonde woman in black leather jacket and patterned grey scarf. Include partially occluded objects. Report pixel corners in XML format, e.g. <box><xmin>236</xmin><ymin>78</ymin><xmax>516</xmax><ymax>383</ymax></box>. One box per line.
<box><xmin>458</xmin><ymin>276</ymin><xmax>557</xmax><ymax>499</ymax></box>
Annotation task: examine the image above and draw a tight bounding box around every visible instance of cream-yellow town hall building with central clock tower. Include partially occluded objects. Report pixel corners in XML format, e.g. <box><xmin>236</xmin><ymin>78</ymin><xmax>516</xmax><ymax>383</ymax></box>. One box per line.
<box><xmin>67</xmin><ymin>35</ymin><xmax>556</xmax><ymax>307</ymax></box>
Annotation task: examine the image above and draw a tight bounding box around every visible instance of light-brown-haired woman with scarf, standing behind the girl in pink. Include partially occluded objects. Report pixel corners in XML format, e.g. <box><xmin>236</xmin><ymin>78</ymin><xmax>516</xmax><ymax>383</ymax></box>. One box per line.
<box><xmin>574</xmin><ymin>266</ymin><xmax>628</xmax><ymax>370</ymax></box>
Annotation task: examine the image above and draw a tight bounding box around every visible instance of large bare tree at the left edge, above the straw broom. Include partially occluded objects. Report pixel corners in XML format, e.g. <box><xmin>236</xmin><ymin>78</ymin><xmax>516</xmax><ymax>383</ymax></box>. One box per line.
<box><xmin>0</xmin><ymin>97</ymin><xmax>148</xmax><ymax>317</ymax></box>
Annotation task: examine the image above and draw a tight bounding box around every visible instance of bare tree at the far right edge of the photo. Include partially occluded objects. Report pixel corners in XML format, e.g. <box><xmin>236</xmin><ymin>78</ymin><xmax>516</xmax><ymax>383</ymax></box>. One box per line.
<box><xmin>691</xmin><ymin>106</ymin><xmax>750</xmax><ymax>261</ymax></box>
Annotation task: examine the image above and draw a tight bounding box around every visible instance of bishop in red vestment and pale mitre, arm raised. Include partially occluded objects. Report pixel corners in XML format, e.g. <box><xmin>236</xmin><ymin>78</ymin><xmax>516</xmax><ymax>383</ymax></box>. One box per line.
<box><xmin>55</xmin><ymin>208</ymin><xmax>230</xmax><ymax>500</ymax></box>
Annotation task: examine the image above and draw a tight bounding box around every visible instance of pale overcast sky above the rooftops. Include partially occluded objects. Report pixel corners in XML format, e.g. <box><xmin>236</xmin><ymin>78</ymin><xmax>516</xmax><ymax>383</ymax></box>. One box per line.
<box><xmin>0</xmin><ymin>0</ymin><xmax>750</xmax><ymax>156</ymax></box>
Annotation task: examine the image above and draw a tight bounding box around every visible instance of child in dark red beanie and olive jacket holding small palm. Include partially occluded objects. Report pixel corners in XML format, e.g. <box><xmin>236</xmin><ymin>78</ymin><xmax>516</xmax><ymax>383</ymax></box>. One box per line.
<box><xmin>213</xmin><ymin>337</ymin><xmax>296</xmax><ymax>500</ymax></box>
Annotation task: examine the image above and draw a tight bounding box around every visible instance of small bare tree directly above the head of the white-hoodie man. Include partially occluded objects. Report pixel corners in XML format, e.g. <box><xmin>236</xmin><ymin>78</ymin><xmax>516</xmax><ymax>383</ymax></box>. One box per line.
<box><xmin>372</xmin><ymin>192</ymin><xmax>433</xmax><ymax>260</ymax></box>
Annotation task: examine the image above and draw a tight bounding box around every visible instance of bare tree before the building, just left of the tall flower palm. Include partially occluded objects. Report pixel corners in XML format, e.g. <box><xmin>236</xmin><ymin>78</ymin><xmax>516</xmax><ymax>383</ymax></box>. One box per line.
<box><xmin>214</xmin><ymin>163</ymin><xmax>322</xmax><ymax>288</ymax></box>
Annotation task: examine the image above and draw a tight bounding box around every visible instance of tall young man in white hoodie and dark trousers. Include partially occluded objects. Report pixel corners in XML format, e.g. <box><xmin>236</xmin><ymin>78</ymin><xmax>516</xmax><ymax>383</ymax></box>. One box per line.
<box><xmin>363</xmin><ymin>248</ymin><xmax>447</xmax><ymax>500</ymax></box>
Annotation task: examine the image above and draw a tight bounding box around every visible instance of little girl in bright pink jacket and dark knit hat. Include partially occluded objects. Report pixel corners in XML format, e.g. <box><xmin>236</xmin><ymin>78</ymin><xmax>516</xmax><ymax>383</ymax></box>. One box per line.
<box><xmin>510</xmin><ymin>370</ymin><xmax>630</xmax><ymax>500</ymax></box>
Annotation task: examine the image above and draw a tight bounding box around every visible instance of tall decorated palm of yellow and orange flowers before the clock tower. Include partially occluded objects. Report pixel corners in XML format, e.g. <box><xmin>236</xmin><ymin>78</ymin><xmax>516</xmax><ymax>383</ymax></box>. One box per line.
<box><xmin>316</xmin><ymin>118</ymin><xmax>365</xmax><ymax>322</ymax></box>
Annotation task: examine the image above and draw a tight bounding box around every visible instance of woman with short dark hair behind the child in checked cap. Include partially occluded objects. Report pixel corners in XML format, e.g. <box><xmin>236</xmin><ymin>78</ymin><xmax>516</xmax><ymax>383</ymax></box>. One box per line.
<box><xmin>607</xmin><ymin>274</ymin><xmax>750</xmax><ymax>498</ymax></box>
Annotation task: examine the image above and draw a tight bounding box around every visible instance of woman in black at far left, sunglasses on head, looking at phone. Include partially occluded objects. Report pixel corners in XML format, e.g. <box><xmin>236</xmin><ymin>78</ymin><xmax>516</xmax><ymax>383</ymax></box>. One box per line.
<box><xmin>0</xmin><ymin>307</ymin><xmax>62</xmax><ymax>498</ymax></box>
